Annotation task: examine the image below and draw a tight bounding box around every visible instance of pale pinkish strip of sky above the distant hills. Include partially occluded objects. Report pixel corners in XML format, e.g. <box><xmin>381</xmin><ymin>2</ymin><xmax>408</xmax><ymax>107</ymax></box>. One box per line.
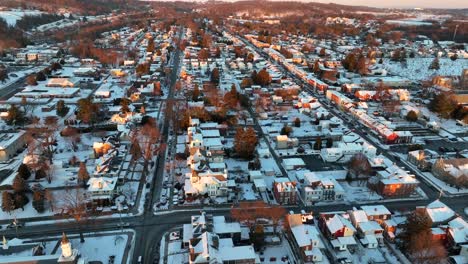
<box><xmin>148</xmin><ymin>0</ymin><xmax>468</xmax><ymax>8</ymax></box>
